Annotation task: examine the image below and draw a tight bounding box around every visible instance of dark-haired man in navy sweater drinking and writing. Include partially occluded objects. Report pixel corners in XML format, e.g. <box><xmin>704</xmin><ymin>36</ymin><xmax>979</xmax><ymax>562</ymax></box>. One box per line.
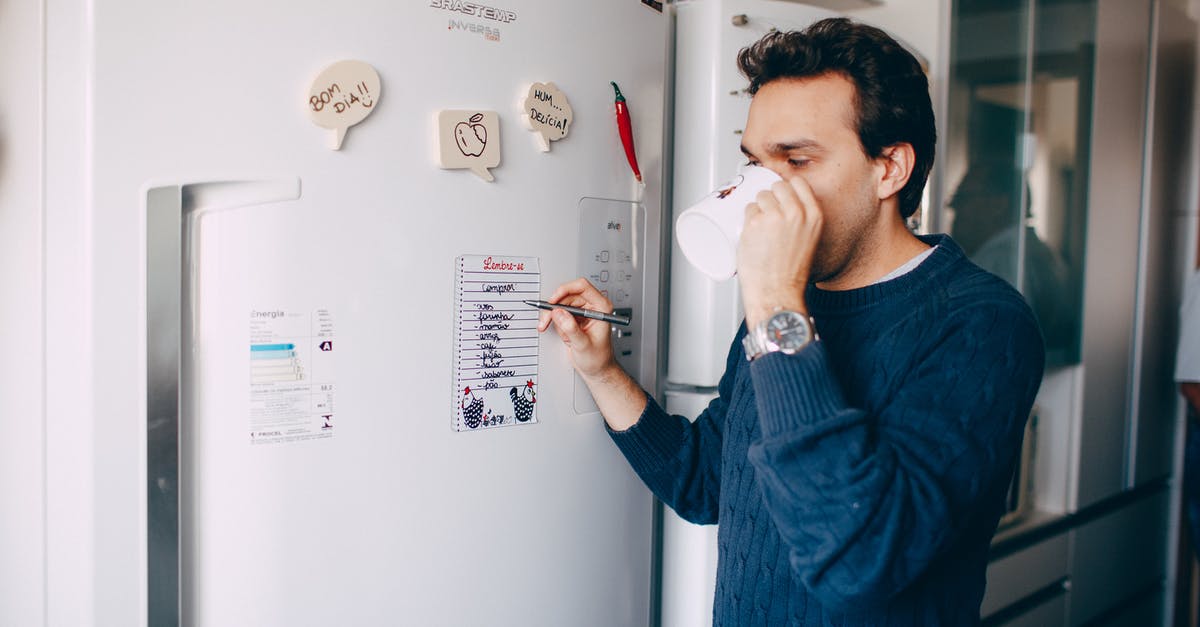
<box><xmin>541</xmin><ymin>19</ymin><xmax>1044</xmax><ymax>627</ymax></box>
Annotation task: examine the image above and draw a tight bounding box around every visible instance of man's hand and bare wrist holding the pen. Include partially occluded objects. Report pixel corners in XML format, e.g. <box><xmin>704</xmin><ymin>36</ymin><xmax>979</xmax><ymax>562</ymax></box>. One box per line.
<box><xmin>538</xmin><ymin>279</ymin><xmax>647</xmax><ymax>431</ymax></box>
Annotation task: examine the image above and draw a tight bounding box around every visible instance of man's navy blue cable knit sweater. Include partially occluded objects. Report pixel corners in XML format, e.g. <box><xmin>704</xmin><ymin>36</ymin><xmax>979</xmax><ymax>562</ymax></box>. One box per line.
<box><xmin>611</xmin><ymin>235</ymin><xmax>1044</xmax><ymax>627</ymax></box>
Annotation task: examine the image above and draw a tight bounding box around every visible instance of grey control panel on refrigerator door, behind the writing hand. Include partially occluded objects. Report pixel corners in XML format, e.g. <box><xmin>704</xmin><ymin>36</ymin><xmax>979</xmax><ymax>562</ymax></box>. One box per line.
<box><xmin>575</xmin><ymin>198</ymin><xmax>646</xmax><ymax>413</ymax></box>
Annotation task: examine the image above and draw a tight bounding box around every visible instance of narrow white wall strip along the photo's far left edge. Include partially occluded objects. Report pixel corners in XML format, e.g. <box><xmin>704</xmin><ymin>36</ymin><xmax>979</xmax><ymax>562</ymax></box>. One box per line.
<box><xmin>0</xmin><ymin>0</ymin><xmax>46</xmax><ymax>626</ymax></box>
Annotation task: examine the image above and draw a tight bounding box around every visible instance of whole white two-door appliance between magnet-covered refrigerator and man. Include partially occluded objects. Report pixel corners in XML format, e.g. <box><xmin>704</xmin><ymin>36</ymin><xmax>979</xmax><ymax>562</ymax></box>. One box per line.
<box><xmin>662</xmin><ymin>0</ymin><xmax>836</xmax><ymax>627</ymax></box>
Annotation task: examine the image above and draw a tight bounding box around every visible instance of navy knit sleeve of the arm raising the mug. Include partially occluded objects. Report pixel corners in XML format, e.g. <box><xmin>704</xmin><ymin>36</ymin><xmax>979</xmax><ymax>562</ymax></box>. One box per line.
<box><xmin>749</xmin><ymin>297</ymin><xmax>1045</xmax><ymax>610</ymax></box>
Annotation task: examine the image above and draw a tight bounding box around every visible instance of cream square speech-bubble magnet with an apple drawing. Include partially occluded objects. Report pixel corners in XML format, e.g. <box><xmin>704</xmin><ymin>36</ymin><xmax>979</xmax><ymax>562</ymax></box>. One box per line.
<box><xmin>437</xmin><ymin>109</ymin><xmax>500</xmax><ymax>181</ymax></box>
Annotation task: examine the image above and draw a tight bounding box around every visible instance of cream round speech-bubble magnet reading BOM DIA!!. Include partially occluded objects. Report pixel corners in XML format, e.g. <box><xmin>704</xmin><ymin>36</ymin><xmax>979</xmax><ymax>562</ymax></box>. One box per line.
<box><xmin>306</xmin><ymin>60</ymin><xmax>382</xmax><ymax>150</ymax></box>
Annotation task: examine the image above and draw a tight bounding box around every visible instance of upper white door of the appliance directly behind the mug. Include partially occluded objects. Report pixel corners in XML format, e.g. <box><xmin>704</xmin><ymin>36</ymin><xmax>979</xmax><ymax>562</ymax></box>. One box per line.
<box><xmin>666</xmin><ymin>0</ymin><xmax>836</xmax><ymax>387</ymax></box>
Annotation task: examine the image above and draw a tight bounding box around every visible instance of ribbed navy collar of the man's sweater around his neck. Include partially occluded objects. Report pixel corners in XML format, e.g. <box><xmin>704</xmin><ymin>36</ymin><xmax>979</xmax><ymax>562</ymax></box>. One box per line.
<box><xmin>804</xmin><ymin>233</ymin><xmax>964</xmax><ymax>314</ymax></box>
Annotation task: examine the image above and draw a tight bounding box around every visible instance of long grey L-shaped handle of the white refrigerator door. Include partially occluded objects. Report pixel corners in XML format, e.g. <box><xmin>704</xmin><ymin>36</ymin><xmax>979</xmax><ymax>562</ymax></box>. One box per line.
<box><xmin>143</xmin><ymin>177</ymin><xmax>300</xmax><ymax>625</ymax></box>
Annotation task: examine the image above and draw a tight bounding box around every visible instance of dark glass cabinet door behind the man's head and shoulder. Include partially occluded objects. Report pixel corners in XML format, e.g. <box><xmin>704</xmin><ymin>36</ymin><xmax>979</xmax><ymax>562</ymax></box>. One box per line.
<box><xmin>935</xmin><ymin>0</ymin><xmax>1096</xmax><ymax>366</ymax></box>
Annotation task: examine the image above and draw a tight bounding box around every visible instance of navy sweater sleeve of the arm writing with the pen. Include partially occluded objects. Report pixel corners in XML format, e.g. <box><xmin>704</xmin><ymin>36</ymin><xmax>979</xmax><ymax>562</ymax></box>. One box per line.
<box><xmin>608</xmin><ymin>326</ymin><xmax>745</xmax><ymax>525</ymax></box>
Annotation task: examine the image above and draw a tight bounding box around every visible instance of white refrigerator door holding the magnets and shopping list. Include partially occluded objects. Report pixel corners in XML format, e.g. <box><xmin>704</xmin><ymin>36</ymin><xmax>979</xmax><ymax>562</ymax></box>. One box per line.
<box><xmin>80</xmin><ymin>0</ymin><xmax>668</xmax><ymax>626</ymax></box>
